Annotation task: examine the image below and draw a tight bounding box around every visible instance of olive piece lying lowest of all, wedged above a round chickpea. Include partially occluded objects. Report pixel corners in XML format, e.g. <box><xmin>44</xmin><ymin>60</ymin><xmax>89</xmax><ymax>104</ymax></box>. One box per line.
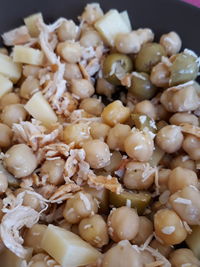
<box><xmin>109</xmin><ymin>191</ymin><xmax>151</xmax><ymax>215</ymax></box>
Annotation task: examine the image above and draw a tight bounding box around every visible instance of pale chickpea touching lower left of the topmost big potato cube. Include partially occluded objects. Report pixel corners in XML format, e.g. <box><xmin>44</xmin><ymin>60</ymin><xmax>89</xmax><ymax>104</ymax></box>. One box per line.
<box><xmin>80</xmin><ymin>30</ymin><xmax>102</xmax><ymax>47</ymax></box>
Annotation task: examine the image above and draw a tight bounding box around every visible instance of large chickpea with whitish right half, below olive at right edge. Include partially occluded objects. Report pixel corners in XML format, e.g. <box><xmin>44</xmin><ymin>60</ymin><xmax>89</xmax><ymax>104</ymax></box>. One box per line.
<box><xmin>160</xmin><ymin>85</ymin><xmax>199</xmax><ymax>112</ymax></box>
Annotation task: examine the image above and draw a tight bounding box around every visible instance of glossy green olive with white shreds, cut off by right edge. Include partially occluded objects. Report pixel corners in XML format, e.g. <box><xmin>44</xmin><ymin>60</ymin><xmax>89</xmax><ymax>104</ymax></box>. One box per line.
<box><xmin>169</xmin><ymin>52</ymin><xmax>199</xmax><ymax>86</ymax></box>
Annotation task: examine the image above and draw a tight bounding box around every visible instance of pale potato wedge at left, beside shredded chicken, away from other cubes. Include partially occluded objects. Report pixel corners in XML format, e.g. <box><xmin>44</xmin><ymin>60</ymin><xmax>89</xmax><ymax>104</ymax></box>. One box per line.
<box><xmin>24</xmin><ymin>92</ymin><xmax>57</xmax><ymax>126</ymax></box>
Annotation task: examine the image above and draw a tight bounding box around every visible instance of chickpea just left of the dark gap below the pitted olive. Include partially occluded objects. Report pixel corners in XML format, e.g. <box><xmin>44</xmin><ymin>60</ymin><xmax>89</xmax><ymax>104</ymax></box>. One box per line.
<box><xmin>71</xmin><ymin>79</ymin><xmax>94</xmax><ymax>99</ymax></box>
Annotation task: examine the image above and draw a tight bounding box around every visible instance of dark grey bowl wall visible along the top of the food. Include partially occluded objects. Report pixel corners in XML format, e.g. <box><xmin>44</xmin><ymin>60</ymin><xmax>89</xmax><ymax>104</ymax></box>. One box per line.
<box><xmin>0</xmin><ymin>0</ymin><xmax>200</xmax><ymax>54</ymax></box>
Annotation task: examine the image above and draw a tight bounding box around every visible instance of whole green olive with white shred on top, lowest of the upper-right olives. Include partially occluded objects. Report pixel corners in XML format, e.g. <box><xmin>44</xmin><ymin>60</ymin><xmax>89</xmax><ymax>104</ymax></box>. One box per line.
<box><xmin>128</xmin><ymin>72</ymin><xmax>157</xmax><ymax>100</ymax></box>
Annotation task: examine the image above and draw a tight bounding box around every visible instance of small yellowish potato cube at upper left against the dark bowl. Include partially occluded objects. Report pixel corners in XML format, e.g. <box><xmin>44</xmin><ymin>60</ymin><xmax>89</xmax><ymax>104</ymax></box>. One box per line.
<box><xmin>24</xmin><ymin>13</ymin><xmax>43</xmax><ymax>37</ymax></box>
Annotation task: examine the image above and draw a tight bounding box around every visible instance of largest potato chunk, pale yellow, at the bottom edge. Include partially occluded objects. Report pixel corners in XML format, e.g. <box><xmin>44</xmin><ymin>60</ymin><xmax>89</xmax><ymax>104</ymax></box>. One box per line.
<box><xmin>41</xmin><ymin>224</ymin><xmax>101</xmax><ymax>267</ymax></box>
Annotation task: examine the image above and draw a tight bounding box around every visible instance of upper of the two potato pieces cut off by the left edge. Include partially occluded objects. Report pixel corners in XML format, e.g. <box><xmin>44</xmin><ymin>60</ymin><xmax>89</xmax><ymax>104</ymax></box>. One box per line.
<box><xmin>0</xmin><ymin>54</ymin><xmax>22</xmax><ymax>83</ymax></box>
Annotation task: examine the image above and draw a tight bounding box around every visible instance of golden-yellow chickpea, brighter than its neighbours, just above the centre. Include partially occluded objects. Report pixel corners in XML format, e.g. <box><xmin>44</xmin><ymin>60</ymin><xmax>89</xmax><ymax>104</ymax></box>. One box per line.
<box><xmin>101</xmin><ymin>100</ymin><xmax>130</xmax><ymax>126</ymax></box>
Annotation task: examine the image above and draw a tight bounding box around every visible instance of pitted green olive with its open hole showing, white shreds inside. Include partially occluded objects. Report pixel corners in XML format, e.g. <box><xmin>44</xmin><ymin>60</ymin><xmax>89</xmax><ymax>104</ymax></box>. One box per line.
<box><xmin>103</xmin><ymin>53</ymin><xmax>133</xmax><ymax>85</ymax></box>
